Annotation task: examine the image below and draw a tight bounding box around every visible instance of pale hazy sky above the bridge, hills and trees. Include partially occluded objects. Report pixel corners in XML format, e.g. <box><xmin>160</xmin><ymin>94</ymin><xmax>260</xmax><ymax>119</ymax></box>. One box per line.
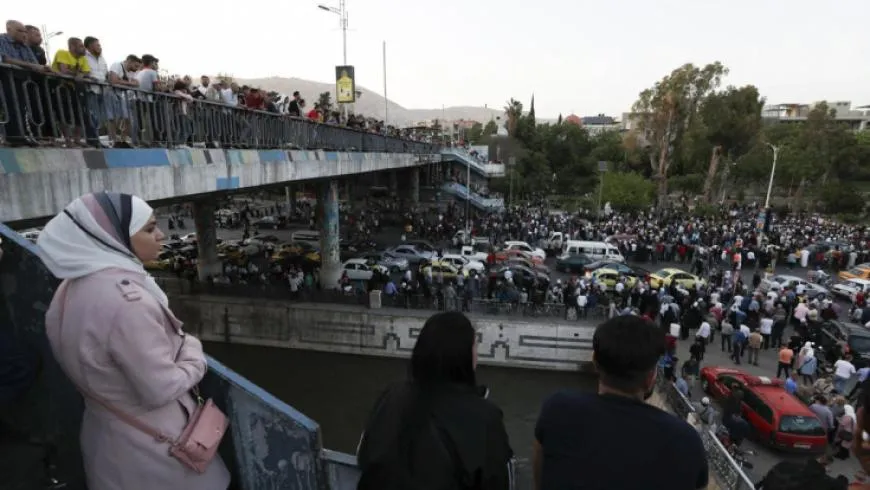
<box><xmin>3</xmin><ymin>0</ymin><xmax>870</xmax><ymax>118</ymax></box>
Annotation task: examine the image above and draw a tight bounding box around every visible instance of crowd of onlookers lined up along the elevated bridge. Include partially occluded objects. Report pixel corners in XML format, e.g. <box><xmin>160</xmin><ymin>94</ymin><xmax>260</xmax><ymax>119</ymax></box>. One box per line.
<box><xmin>0</xmin><ymin>20</ymin><xmax>431</xmax><ymax>148</ymax></box>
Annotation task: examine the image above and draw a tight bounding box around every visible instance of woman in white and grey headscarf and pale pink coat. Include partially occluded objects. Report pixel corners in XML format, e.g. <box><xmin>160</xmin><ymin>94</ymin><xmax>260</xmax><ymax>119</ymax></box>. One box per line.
<box><xmin>37</xmin><ymin>192</ymin><xmax>229</xmax><ymax>490</ymax></box>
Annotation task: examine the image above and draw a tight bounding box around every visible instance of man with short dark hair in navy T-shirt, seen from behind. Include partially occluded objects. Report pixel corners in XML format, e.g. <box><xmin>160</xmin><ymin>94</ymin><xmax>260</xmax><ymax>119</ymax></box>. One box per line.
<box><xmin>534</xmin><ymin>316</ymin><xmax>708</xmax><ymax>490</ymax></box>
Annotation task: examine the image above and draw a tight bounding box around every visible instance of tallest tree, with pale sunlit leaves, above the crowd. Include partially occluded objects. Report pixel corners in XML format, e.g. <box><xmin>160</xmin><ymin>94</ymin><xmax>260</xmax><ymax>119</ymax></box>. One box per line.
<box><xmin>632</xmin><ymin>61</ymin><xmax>728</xmax><ymax>206</ymax></box>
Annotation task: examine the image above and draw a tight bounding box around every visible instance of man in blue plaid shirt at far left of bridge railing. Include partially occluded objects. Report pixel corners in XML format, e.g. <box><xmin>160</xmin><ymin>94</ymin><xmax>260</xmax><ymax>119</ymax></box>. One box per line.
<box><xmin>0</xmin><ymin>20</ymin><xmax>51</xmax><ymax>146</ymax></box>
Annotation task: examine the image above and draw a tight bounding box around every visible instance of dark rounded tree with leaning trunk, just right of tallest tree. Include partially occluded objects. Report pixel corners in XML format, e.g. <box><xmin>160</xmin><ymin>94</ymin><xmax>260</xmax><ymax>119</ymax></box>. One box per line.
<box><xmin>701</xmin><ymin>85</ymin><xmax>764</xmax><ymax>202</ymax></box>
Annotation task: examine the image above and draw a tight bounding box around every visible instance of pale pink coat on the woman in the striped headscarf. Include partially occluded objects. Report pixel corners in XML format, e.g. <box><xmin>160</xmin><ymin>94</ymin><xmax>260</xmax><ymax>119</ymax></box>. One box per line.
<box><xmin>45</xmin><ymin>269</ymin><xmax>230</xmax><ymax>490</ymax></box>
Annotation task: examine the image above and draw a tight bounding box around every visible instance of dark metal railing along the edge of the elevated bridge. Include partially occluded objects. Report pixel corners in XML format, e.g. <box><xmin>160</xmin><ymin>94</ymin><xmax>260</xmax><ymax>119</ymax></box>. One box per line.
<box><xmin>0</xmin><ymin>63</ymin><xmax>439</xmax><ymax>154</ymax></box>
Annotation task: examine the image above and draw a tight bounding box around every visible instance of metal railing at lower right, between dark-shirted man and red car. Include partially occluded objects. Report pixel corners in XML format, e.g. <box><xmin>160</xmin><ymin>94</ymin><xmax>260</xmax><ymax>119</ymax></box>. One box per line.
<box><xmin>656</xmin><ymin>366</ymin><xmax>755</xmax><ymax>490</ymax></box>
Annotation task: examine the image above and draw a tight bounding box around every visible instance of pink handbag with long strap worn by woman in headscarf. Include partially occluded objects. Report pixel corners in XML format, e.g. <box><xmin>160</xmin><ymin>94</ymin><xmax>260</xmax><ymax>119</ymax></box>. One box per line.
<box><xmin>59</xmin><ymin>282</ymin><xmax>229</xmax><ymax>474</ymax></box>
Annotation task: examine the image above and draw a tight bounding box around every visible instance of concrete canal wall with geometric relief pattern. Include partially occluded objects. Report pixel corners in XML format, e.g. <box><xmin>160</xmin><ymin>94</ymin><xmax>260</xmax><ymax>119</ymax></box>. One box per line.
<box><xmin>172</xmin><ymin>295</ymin><xmax>595</xmax><ymax>371</ymax></box>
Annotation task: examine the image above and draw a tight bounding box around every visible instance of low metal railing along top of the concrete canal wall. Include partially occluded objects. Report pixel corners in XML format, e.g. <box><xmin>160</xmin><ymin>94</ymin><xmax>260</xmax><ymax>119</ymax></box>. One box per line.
<box><xmin>155</xmin><ymin>276</ymin><xmax>592</xmax><ymax>321</ymax></box>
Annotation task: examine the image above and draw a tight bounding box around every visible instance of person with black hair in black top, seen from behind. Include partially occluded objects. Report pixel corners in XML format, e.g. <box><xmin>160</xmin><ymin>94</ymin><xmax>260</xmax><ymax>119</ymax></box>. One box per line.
<box><xmin>357</xmin><ymin>311</ymin><xmax>513</xmax><ymax>490</ymax></box>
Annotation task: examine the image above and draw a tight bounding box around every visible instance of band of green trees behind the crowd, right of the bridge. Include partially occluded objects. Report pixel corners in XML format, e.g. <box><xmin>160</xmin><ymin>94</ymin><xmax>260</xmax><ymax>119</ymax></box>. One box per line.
<box><xmin>498</xmin><ymin>62</ymin><xmax>870</xmax><ymax>213</ymax></box>
